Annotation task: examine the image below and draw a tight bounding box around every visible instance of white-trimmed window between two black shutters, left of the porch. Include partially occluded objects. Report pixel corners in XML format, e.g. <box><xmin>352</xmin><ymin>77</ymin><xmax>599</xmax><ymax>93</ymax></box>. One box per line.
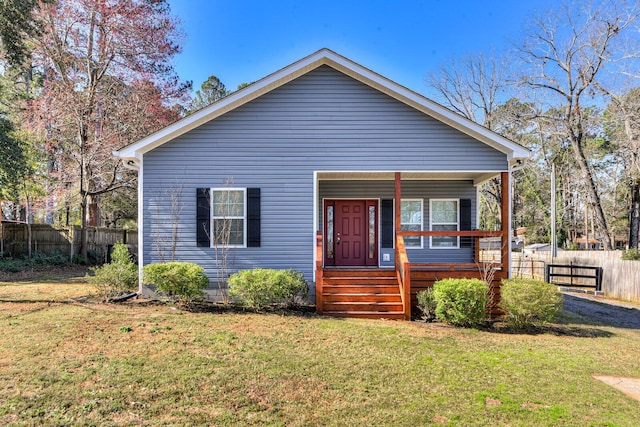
<box><xmin>211</xmin><ymin>188</ymin><xmax>247</xmax><ymax>248</ymax></box>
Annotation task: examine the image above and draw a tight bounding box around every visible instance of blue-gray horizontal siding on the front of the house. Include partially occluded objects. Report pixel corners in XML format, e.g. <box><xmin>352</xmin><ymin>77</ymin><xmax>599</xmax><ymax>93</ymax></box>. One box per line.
<box><xmin>143</xmin><ymin>66</ymin><xmax>507</xmax><ymax>288</ymax></box>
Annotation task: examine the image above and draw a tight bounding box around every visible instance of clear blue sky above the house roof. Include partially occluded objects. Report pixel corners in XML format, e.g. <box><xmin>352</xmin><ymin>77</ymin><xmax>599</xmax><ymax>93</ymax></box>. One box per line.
<box><xmin>169</xmin><ymin>0</ymin><xmax>558</xmax><ymax>95</ymax></box>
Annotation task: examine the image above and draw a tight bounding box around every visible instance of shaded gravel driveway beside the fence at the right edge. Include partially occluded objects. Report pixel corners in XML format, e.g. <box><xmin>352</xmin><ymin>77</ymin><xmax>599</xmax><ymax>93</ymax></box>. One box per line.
<box><xmin>564</xmin><ymin>293</ymin><xmax>640</xmax><ymax>329</ymax></box>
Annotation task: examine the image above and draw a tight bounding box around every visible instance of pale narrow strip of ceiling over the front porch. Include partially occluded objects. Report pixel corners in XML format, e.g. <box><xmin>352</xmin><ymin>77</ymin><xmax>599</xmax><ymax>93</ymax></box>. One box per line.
<box><xmin>318</xmin><ymin>171</ymin><xmax>501</xmax><ymax>185</ymax></box>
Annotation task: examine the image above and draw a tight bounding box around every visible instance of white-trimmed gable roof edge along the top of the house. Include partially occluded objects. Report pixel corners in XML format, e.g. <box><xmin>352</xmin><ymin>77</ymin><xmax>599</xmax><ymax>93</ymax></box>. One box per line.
<box><xmin>113</xmin><ymin>49</ymin><xmax>530</xmax><ymax>165</ymax></box>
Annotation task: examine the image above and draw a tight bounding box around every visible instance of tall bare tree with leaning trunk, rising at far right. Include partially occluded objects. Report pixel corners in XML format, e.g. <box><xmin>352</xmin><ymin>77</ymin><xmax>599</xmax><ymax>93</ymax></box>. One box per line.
<box><xmin>520</xmin><ymin>1</ymin><xmax>638</xmax><ymax>249</ymax></box>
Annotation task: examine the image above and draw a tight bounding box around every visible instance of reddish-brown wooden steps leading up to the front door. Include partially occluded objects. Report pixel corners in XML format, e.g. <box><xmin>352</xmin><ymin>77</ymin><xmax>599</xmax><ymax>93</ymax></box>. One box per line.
<box><xmin>322</xmin><ymin>269</ymin><xmax>404</xmax><ymax>319</ymax></box>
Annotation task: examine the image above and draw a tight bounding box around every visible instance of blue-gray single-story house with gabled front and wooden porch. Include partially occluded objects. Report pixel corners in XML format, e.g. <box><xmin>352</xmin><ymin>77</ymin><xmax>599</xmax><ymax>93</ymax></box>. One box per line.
<box><xmin>114</xmin><ymin>49</ymin><xmax>529</xmax><ymax>318</ymax></box>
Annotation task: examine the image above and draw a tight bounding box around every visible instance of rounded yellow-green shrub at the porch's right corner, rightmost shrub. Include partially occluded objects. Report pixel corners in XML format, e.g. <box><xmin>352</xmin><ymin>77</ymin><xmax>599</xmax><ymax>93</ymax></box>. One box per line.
<box><xmin>500</xmin><ymin>279</ymin><xmax>563</xmax><ymax>329</ymax></box>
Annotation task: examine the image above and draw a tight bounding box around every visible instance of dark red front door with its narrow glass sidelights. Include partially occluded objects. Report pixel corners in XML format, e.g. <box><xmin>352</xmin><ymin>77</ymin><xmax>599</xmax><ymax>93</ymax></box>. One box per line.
<box><xmin>325</xmin><ymin>200</ymin><xmax>378</xmax><ymax>266</ymax></box>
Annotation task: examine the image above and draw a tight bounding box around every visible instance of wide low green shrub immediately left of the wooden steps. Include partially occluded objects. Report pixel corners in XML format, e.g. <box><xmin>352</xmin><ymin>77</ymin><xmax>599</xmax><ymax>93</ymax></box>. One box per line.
<box><xmin>229</xmin><ymin>268</ymin><xmax>309</xmax><ymax>309</ymax></box>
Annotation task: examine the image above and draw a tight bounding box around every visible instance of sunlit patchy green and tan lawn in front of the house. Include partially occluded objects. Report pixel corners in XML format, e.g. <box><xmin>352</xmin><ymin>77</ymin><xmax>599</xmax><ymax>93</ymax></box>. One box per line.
<box><xmin>0</xmin><ymin>276</ymin><xmax>640</xmax><ymax>426</ymax></box>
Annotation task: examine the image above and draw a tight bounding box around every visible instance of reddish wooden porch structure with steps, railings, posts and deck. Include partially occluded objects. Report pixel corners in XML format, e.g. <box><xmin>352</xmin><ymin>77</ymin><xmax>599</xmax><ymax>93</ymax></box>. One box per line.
<box><xmin>315</xmin><ymin>172</ymin><xmax>511</xmax><ymax>320</ymax></box>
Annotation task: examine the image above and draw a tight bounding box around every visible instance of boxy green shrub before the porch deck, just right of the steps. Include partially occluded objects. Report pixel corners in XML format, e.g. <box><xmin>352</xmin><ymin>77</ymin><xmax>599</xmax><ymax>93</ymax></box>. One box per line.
<box><xmin>433</xmin><ymin>279</ymin><xmax>489</xmax><ymax>326</ymax></box>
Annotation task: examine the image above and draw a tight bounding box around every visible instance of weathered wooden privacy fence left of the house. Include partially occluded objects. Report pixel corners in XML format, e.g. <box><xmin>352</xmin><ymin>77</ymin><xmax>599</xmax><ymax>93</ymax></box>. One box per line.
<box><xmin>0</xmin><ymin>223</ymin><xmax>138</xmax><ymax>261</ymax></box>
